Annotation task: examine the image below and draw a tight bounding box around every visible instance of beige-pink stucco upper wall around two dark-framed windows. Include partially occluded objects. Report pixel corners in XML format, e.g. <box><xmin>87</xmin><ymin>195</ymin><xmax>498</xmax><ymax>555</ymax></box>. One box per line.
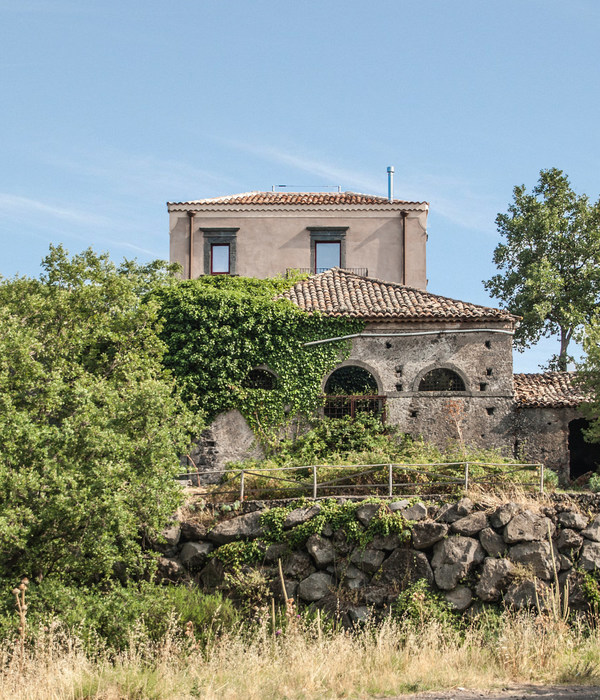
<box><xmin>170</xmin><ymin>205</ymin><xmax>427</xmax><ymax>289</ymax></box>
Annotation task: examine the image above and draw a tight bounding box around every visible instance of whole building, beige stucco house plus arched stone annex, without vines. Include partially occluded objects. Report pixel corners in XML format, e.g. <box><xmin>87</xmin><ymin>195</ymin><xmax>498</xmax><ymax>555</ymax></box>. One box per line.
<box><xmin>168</xmin><ymin>192</ymin><xmax>600</xmax><ymax>480</ymax></box>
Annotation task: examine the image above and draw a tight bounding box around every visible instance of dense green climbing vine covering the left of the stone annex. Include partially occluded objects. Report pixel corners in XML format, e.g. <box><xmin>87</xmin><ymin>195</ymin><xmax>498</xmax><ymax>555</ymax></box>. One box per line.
<box><xmin>153</xmin><ymin>276</ymin><xmax>364</xmax><ymax>444</ymax></box>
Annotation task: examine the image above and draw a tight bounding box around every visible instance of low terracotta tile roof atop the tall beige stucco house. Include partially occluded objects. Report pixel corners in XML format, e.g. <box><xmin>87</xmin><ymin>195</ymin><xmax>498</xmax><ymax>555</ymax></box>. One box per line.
<box><xmin>168</xmin><ymin>192</ymin><xmax>427</xmax><ymax>207</ymax></box>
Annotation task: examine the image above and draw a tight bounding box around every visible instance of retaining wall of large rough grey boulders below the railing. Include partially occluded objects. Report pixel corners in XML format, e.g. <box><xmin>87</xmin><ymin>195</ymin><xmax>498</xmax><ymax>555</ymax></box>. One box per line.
<box><xmin>159</xmin><ymin>496</ymin><xmax>600</xmax><ymax>622</ymax></box>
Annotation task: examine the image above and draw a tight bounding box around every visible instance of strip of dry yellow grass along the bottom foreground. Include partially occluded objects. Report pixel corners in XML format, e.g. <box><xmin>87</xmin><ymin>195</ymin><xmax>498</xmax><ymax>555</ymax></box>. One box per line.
<box><xmin>0</xmin><ymin>615</ymin><xmax>600</xmax><ymax>700</ymax></box>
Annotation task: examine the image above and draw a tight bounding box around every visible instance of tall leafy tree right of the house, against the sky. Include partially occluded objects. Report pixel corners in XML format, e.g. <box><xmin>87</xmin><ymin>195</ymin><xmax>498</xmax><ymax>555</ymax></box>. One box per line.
<box><xmin>484</xmin><ymin>168</ymin><xmax>600</xmax><ymax>371</ymax></box>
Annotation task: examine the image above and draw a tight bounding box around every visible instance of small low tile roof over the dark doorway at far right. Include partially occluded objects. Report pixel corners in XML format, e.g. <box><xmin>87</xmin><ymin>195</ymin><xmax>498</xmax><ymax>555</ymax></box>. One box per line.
<box><xmin>513</xmin><ymin>372</ymin><xmax>586</xmax><ymax>408</ymax></box>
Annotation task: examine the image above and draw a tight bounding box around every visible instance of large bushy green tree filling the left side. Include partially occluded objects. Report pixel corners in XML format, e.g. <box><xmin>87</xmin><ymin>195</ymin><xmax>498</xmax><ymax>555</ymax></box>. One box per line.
<box><xmin>0</xmin><ymin>247</ymin><xmax>192</xmax><ymax>583</ymax></box>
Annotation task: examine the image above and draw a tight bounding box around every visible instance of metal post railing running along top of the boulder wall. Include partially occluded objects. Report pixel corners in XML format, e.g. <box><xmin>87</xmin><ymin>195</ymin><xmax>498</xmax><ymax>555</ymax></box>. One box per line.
<box><xmin>179</xmin><ymin>462</ymin><xmax>544</xmax><ymax>501</ymax></box>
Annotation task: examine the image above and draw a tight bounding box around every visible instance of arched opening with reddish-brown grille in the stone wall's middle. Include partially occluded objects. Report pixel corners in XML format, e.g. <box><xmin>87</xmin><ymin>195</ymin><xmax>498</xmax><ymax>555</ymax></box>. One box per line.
<box><xmin>323</xmin><ymin>365</ymin><xmax>385</xmax><ymax>420</ymax></box>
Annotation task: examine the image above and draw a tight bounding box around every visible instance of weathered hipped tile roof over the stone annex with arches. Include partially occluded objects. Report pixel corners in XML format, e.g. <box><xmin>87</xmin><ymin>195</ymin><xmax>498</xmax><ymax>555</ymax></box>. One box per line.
<box><xmin>283</xmin><ymin>268</ymin><xmax>516</xmax><ymax>321</ymax></box>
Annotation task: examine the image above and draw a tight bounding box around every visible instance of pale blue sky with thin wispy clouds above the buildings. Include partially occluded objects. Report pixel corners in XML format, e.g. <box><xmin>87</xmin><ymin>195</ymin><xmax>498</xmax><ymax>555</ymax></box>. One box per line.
<box><xmin>0</xmin><ymin>0</ymin><xmax>600</xmax><ymax>371</ymax></box>
